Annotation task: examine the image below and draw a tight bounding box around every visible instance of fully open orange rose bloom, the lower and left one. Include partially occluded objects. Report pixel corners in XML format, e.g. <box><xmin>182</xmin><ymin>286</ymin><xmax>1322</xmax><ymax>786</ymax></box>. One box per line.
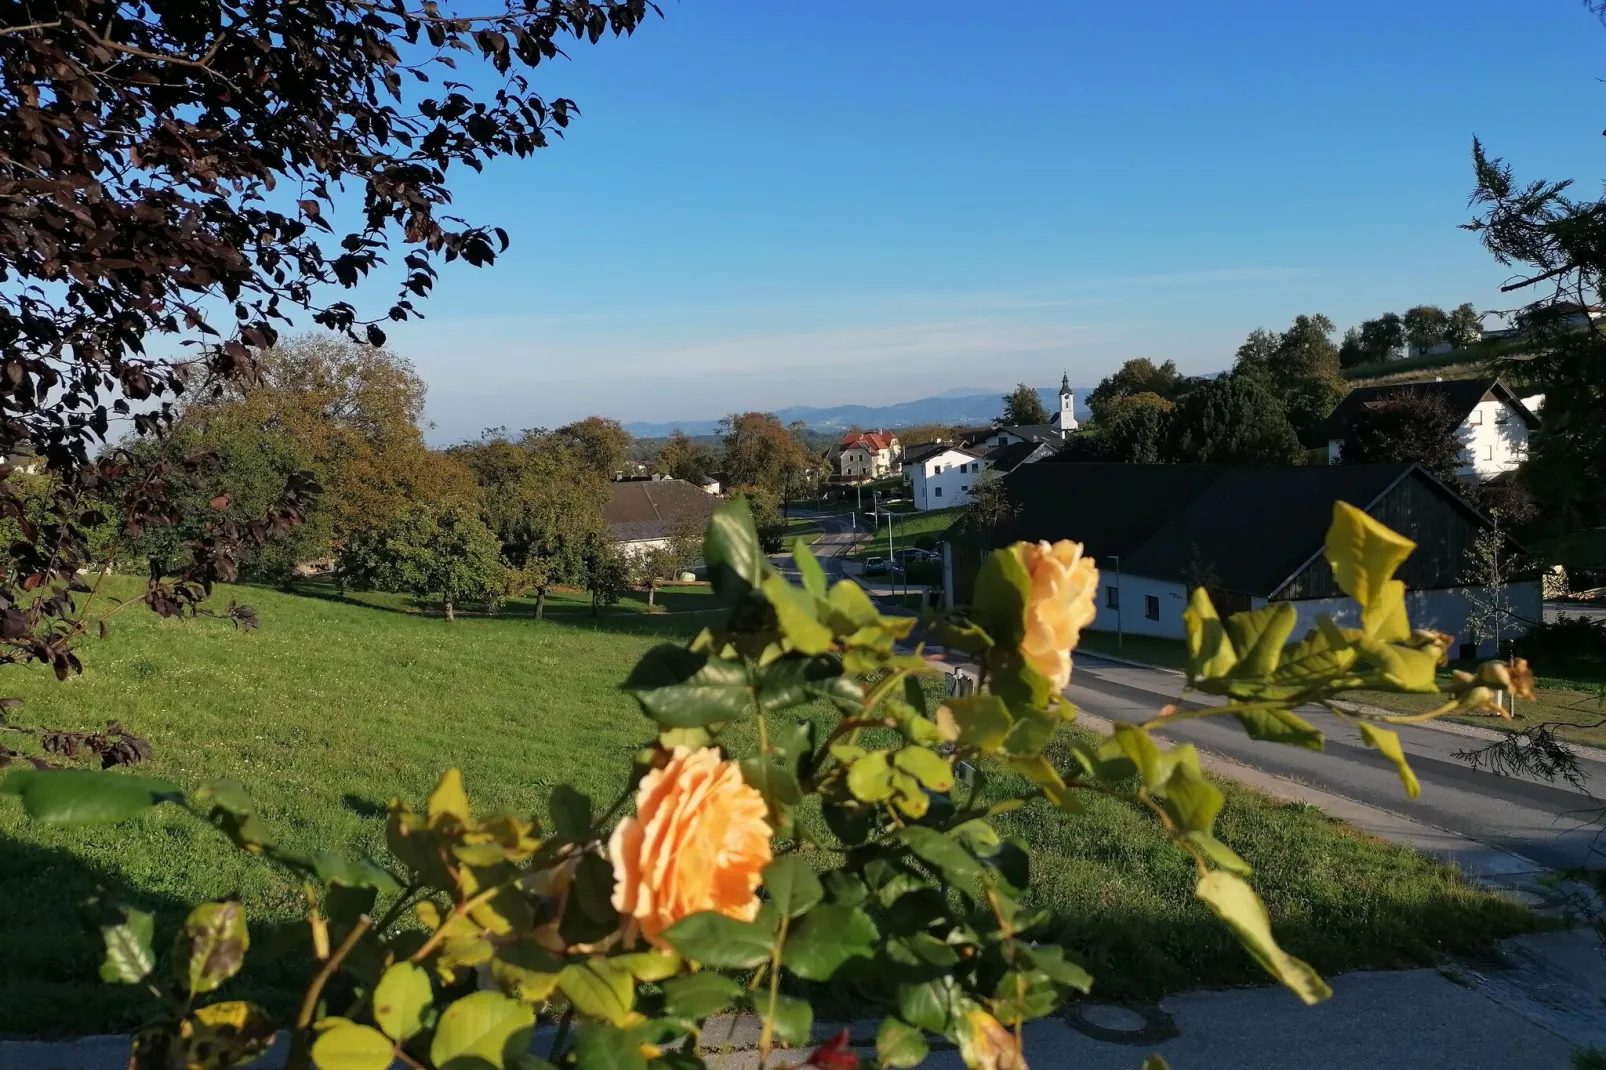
<box><xmin>609</xmin><ymin>747</ymin><xmax>771</xmax><ymax>948</ymax></box>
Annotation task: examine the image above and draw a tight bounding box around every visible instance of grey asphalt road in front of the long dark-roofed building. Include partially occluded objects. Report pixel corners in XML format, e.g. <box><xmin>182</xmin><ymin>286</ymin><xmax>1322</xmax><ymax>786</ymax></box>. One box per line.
<box><xmin>1066</xmin><ymin>654</ymin><xmax>1606</xmax><ymax>869</ymax></box>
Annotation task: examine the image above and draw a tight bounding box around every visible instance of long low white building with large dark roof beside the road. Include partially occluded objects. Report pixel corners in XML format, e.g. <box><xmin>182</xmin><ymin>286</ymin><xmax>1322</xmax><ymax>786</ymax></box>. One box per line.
<box><xmin>943</xmin><ymin>463</ymin><xmax>1542</xmax><ymax>659</ymax></box>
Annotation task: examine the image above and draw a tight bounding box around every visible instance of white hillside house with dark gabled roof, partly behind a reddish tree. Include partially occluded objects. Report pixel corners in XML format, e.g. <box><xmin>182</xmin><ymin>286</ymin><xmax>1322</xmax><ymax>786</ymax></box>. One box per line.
<box><xmin>1310</xmin><ymin>372</ymin><xmax>1539</xmax><ymax>482</ymax></box>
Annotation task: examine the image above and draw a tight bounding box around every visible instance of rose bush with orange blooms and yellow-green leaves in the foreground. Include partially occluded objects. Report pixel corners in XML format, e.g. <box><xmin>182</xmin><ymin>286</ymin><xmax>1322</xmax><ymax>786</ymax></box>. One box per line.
<box><xmin>0</xmin><ymin>501</ymin><xmax>1532</xmax><ymax>1070</ymax></box>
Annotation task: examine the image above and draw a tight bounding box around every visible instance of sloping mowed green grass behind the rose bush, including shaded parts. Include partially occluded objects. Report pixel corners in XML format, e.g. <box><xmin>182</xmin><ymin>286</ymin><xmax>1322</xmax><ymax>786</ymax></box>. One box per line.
<box><xmin>0</xmin><ymin>575</ymin><xmax>1532</xmax><ymax>1035</ymax></box>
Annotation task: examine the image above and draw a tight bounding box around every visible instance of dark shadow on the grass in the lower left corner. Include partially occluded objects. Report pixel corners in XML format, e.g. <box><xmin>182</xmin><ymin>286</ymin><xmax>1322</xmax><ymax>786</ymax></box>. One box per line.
<box><xmin>0</xmin><ymin>835</ymin><xmax>312</xmax><ymax>1038</ymax></box>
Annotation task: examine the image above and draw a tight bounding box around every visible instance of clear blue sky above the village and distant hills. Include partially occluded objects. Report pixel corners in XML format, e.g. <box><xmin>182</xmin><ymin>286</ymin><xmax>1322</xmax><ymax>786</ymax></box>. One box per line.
<box><xmin>361</xmin><ymin>0</ymin><xmax>1606</xmax><ymax>442</ymax></box>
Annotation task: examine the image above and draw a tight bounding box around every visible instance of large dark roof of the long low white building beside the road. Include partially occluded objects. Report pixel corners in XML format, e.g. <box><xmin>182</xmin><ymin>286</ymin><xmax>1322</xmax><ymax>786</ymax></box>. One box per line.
<box><xmin>957</xmin><ymin>463</ymin><xmax>1487</xmax><ymax>598</ymax></box>
